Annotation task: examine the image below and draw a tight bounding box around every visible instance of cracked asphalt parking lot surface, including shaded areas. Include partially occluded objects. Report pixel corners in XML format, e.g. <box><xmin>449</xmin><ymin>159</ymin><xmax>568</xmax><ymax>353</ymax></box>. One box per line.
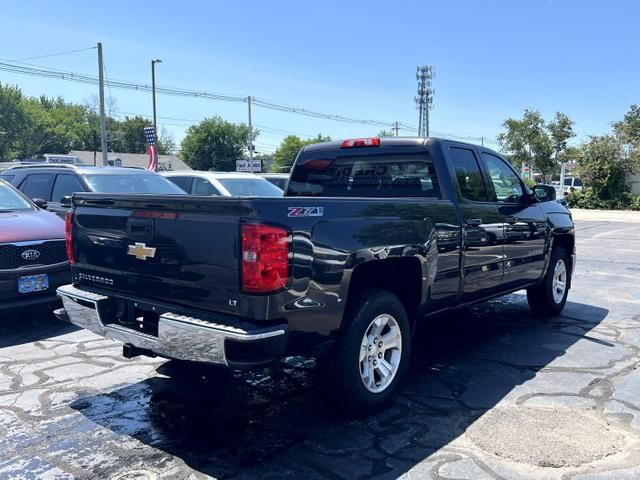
<box><xmin>0</xmin><ymin>221</ymin><xmax>640</xmax><ymax>480</ymax></box>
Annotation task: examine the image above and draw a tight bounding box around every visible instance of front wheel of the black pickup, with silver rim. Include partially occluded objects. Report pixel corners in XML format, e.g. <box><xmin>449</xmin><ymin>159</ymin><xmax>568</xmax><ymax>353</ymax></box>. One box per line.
<box><xmin>527</xmin><ymin>247</ymin><xmax>572</xmax><ymax>317</ymax></box>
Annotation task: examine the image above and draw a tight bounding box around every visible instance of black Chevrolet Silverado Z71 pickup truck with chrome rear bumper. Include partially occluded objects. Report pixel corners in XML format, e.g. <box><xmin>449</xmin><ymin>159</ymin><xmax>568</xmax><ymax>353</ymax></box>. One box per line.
<box><xmin>56</xmin><ymin>138</ymin><xmax>575</xmax><ymax>413</ymax></box>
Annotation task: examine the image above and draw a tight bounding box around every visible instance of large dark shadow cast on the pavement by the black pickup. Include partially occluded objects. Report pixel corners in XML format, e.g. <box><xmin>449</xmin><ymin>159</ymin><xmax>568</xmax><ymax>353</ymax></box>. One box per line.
<box><xmin>72</xmin><ymin>294</ymin><xmax>611</xmax><ymax>479</ymax></box>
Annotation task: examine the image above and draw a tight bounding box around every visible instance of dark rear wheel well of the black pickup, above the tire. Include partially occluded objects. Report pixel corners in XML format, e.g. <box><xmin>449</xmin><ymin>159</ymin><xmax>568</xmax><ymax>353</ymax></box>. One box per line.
<box><xmin>345</xmin><ymin>257</ymin><xmax>422</xmax><ymax>327</ymax></box>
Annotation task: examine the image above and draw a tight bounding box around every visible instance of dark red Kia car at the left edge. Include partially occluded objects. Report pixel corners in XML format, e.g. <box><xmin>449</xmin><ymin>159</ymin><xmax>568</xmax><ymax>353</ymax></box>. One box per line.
<box><xmin>0</xmin><ymin>180</ymin><xmax>71</xmax><ymax>317</ymax></box>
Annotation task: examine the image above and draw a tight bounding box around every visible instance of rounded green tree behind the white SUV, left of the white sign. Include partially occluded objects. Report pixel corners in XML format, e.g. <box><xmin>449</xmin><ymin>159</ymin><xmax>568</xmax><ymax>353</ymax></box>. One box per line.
<box><xmin>179</xmin><ymin>117</ymin><xmax>258</xmax><ymax>171</ymax></box>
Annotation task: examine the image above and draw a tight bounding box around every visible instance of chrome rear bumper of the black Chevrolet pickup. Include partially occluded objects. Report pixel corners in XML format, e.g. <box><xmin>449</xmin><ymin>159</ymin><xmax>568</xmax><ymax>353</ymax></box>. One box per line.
<box><xmin>55</xmin><ymin>285</ymin><xmax>287</xmax><ymax>366</ymax></box>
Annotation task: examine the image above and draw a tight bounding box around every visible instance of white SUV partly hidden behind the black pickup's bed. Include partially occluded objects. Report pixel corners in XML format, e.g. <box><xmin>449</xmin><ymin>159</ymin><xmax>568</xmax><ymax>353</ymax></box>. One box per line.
<box><xmin>161</xmin><ymin>170</ymin><xmax>283</xmax><ymax>197</ymax></box>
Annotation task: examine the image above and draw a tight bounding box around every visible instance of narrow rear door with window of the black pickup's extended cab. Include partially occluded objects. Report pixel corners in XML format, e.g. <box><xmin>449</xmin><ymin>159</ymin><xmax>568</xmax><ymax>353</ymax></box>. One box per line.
<box><xmin>449</xmin><ymin>145</ymin><xmax>504</xmax><ymax>302</ymax></box>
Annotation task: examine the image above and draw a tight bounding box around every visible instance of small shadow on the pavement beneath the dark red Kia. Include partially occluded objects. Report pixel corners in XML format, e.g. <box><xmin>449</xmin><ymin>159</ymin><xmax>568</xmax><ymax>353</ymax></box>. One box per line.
<box><xmin>0</xmin><ymin>309</ymin><xmax>78</xmax><ymax>348</ymax></box>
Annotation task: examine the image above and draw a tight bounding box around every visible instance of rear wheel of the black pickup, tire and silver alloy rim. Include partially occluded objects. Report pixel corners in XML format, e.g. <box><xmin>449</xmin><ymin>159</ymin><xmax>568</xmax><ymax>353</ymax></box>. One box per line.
<box><xmin>322</xmin><ymin>289</ymin><xmax>411</xmax><ymax>416</ymax></box>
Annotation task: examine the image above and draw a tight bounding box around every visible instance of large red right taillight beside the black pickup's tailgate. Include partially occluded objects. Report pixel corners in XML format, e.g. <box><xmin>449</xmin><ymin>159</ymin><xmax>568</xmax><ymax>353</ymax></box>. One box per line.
<box><xmin>242</xmin><ymin>224</ymin><xmax>291</xmax><ymax>293</ymax></box>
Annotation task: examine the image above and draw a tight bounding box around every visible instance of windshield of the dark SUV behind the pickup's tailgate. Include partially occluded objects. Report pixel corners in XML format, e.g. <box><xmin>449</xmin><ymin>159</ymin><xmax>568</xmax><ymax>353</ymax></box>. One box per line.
<box><xmin>86</xmin><ymin>173</ymin><xmax>185</xmax><ymax>195</ymax></box>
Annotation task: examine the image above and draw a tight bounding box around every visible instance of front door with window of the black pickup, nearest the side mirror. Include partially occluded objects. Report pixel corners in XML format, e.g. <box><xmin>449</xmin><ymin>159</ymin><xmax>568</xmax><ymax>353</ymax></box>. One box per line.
<box><xmin>482</xmin><ymin>151</ymin><xmax>547</xmax><ymax>288</ymax></box>
